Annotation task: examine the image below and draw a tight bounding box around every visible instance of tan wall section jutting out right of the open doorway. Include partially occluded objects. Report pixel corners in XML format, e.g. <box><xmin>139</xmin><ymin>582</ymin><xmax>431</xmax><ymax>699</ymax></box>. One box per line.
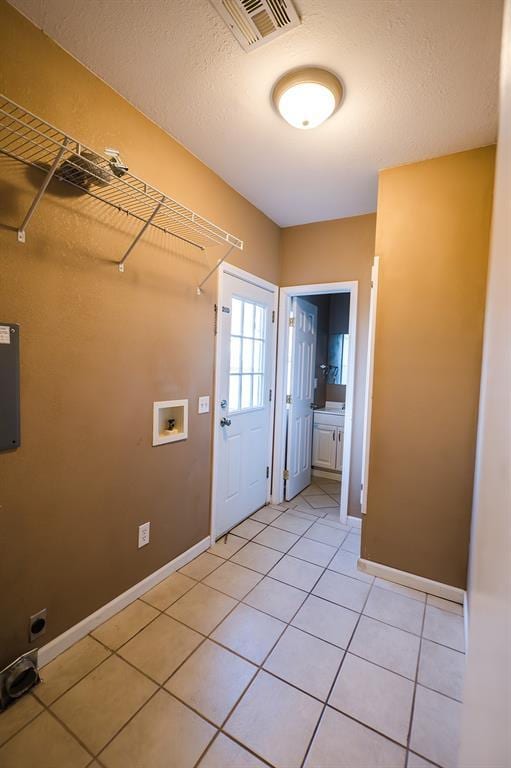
<box><xmin>362</xmin><ymin>147</ymin><xmax>494</xmax><ymax>587</ymax></box>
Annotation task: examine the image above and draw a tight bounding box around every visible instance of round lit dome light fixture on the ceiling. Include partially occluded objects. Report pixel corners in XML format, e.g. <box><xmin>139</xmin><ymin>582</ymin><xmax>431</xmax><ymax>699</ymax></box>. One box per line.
<box><xmin>272</xmin><ymin>67</ymin><xmax>343</xmax><ymax>130</ymax></box>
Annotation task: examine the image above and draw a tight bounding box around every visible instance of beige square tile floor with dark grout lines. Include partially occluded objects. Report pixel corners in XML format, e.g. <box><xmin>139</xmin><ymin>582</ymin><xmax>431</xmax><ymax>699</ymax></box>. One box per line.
<box><xmin>0</xmin><ymin>478</ymin><xmax>464</xmax><ymax>768</ymax></box>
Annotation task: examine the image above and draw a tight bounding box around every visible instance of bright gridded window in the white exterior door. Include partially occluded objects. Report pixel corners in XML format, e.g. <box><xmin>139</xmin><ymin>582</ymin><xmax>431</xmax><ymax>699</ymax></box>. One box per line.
<box><xmin>229</xmin><ymin>298</ymin><xmax>267</xmax><ymax>413</ymax></box>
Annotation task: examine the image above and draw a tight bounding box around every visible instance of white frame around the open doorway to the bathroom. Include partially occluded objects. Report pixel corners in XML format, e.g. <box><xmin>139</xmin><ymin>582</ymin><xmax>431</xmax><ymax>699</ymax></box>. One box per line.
<box><xmin>272</xmin><ymin>280</ymin><xmax>358</xmax><ymax>522</ymax></box>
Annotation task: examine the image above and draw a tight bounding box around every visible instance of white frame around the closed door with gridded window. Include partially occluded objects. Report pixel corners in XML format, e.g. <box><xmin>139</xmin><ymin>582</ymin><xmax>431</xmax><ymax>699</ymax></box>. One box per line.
<box><xmin>210</xmin><ymin>261</ymin><xmax>279</xmax><ymax>545</ymax></box>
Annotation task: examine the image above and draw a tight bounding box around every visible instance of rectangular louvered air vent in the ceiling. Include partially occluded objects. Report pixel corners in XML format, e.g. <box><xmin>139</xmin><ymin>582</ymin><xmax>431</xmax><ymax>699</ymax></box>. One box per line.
<box><xmin>211</xmin><ymin>0</ymin><xmax>300</xmax><ymax>51</ymax></box>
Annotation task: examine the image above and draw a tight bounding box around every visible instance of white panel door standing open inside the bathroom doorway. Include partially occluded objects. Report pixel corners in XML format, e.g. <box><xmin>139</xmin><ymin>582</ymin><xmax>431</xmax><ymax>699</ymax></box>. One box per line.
<box><xmin>286</xmin><ymin>297</ymin><xmax>318</xmax><ymax>501</ymax></box>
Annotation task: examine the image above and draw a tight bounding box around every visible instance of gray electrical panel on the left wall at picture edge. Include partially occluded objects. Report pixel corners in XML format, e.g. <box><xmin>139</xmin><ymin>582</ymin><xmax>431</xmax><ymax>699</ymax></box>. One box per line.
<box><xmin>0</xmin><ymin>322</ymin><xmax>20</xmax><ymax>451</ymax></box>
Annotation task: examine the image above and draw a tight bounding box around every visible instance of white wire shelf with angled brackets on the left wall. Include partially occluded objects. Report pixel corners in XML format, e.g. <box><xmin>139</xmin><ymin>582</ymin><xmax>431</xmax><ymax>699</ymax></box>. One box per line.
<box><xmin>0</xmin><ymin>94</ymin><xmax>243</xmax><ymax>294</ymax></box>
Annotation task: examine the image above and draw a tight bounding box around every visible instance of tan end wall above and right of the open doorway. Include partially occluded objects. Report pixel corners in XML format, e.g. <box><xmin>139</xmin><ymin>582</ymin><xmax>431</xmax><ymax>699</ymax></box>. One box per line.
<box><xmin>280</xmin><ymin>214</ymin><xmax>376</xmax><ymax>515</ymax></box>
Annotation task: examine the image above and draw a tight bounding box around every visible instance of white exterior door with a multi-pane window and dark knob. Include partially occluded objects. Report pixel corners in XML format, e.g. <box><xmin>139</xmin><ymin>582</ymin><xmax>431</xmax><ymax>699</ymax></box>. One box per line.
<box><xmin>213</xmin><ymin>273</ymin><xmax>275</xmax><ymax>536</ymax></box>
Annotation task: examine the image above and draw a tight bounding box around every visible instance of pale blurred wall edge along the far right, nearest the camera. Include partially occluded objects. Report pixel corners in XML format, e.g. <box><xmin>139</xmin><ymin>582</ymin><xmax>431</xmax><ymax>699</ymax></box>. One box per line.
<box><xmin>459</xmin><ymin>0</ymin><xmax>511</xmax><ymax>768</ymax></box>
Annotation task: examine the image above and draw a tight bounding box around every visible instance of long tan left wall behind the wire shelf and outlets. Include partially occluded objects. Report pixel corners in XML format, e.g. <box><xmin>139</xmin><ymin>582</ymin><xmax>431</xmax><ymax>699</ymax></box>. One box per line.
<box><xmin>0</xmin><ymin>0</ymin><xmax>279</xmax><ymax>667</ymax></box>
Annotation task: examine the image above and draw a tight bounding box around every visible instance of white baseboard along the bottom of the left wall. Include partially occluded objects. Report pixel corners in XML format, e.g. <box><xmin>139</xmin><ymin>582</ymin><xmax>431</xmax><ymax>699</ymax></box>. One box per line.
<box><xmin>38</xmin><ymin>536</ymin><xmax>211</xmax><ymax>667</ymax></box>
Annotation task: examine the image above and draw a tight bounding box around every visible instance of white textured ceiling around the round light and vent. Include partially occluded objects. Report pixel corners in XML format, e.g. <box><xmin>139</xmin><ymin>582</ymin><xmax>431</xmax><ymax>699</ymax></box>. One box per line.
<box><xmin>11</xmin><ymin>0</ymin><xmax>502</xmax><ymax>226</ymax></box>
